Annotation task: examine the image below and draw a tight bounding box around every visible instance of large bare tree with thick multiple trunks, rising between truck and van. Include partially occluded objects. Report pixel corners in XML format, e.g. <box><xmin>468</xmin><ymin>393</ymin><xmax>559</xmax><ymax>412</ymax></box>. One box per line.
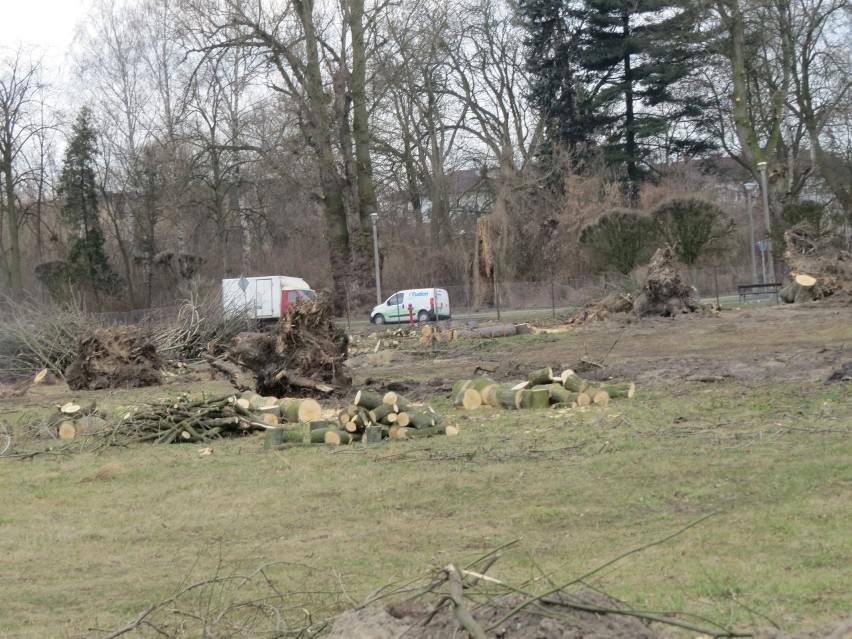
<box><xmin>185</xmin><ymin>0</ymin><xmax>381</xmax><ymax>299</ymax></box>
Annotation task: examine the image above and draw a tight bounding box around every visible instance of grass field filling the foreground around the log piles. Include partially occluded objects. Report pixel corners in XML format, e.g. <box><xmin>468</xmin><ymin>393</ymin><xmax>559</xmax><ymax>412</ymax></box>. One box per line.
<box><xmin>0</xmin><ymin>308</ymin><xmax>852</xmax><ymax>639</ymax></box>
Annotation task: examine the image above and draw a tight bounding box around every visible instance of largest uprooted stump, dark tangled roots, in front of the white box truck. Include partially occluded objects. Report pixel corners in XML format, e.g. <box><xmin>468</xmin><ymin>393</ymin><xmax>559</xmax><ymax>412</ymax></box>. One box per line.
<box><xmin>221</xmin><ymin>293</ymin><xmax>352</xmax><ymax>397</ymax></box>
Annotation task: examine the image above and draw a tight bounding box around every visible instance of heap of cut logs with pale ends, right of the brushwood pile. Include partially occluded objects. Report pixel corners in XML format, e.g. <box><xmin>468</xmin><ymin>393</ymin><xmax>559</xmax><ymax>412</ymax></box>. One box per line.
<box><xmin>311</xmin><ymin>390</ymin><xmax>459</xmax><ymax>444</ymax></box>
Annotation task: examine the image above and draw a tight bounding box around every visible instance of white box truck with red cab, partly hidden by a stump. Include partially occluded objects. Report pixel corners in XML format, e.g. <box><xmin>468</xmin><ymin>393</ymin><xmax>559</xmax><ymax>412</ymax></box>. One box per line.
<box><xmin>222</xmin><ymin>275</ymin><xmax>317</xmax><ymax>320</ymax></box>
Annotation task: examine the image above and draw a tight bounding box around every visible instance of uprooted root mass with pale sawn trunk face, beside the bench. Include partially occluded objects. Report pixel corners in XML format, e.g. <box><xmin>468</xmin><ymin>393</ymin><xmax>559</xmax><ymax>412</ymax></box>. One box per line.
<box><xmin>779</xmin><ymin>222</ymin><xmax>852</xmax><ymax>302</ymax></box>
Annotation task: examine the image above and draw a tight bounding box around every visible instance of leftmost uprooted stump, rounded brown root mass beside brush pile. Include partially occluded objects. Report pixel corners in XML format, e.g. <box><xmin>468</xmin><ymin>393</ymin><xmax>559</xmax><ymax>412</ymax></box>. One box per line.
<box><xmin>65</xmin><ymin>326</ymin><xmax>162</xmax><ymax>390</ymax></box>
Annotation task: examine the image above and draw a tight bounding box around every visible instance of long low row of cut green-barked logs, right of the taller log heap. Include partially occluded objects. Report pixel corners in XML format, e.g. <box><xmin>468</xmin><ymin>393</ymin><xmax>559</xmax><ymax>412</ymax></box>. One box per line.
<box><xmin>452</xmin><ymin>368</ymin><xmax>636</xmax><ymax>410</ymax></box>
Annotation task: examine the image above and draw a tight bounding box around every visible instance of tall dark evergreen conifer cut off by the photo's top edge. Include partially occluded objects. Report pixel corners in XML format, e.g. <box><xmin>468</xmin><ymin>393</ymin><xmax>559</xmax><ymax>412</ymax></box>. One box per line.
<box><xmin>520</xmin><ymin>0</ymin><xmax>710</xmax><ymax>202</ymax></box>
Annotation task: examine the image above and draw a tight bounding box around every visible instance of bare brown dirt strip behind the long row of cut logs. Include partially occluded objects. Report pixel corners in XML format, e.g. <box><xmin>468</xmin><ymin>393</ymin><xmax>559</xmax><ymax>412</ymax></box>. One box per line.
<box><xmin>349</xmin><ymin>299</ymin><xmax>852</xmax><ymax>396</ymax></box>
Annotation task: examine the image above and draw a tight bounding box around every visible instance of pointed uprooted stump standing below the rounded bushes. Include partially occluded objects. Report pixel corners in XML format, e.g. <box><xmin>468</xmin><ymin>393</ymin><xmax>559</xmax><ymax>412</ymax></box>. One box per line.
<box><xmin>633</xmin><ymin>246</ymin><xmax>701</xmax><ymax>317</ymax></box>
